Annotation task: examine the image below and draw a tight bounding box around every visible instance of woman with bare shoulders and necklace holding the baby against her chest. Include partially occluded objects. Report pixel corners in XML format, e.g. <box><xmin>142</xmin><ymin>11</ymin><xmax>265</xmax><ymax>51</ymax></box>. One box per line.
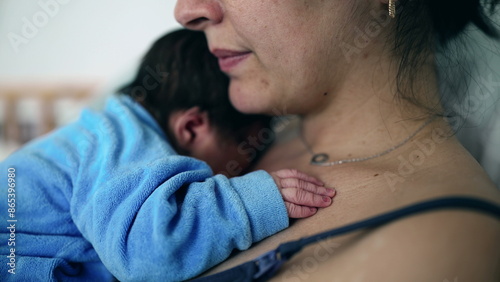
<box><xmin>176</xmin><ymin>0</ymin><xmax>500</xmax><ymax>281</ymax></box>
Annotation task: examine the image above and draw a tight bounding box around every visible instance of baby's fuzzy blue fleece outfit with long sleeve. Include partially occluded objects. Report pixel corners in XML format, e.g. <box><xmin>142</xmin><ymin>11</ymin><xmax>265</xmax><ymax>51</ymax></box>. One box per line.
<box><xmin>0</xmin><ymin>97</ymin><xmax>288</xmax><ymax>281</ymax></box>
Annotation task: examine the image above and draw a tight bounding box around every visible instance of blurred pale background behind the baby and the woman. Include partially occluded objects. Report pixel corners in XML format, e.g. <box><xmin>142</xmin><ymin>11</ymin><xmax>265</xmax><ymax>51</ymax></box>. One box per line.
<box><xmin>0</xmin><ymin>0</ymin><xmax>500</xmax><ymax>186</ymax></box>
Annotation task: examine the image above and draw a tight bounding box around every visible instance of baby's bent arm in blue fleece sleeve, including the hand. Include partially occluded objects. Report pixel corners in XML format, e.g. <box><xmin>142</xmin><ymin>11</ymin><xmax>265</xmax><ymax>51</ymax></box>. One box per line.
<box><xmin>63</xmin><ymin>98</ymin><xmax>336</xmax><ymax>280</ymax></box>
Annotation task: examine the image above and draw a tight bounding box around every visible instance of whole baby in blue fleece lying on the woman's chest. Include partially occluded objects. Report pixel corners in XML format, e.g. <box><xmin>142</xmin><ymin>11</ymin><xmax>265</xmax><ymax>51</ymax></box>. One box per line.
<box><xmin>0</xmin><ymin>30</ymin><xmax>335</xmax><ymax>281</ymax></box>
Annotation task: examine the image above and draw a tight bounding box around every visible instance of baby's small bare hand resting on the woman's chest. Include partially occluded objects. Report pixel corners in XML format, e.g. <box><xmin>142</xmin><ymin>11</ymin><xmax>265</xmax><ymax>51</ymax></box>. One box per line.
<box><xmin>270</xmin><ymin>169</ymin><xmax>335</xmax><ymax>218</ymax></box>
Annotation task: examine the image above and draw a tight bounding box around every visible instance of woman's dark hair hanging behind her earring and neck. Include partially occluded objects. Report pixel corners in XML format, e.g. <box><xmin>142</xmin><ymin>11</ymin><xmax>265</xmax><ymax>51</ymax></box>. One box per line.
<box><xmin>393</xmin><ymin>0</ymin><xmax>500</xmax><ymax>116</ymax></box>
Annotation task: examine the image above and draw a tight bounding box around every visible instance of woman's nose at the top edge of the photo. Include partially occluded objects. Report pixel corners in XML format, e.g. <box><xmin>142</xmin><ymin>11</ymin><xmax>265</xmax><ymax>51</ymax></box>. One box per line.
<box><xmin>175</xmin><ymin>0</ymin><xmax>223</xmax><ymax>30</ymax></box>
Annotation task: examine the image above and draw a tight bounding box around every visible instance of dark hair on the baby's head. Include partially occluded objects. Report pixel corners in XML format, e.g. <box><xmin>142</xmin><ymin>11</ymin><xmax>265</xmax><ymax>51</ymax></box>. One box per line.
<box><xmin>119</xmin><ymin>29</ymin><xmax>271</xmax><ymax>149</ymax></box>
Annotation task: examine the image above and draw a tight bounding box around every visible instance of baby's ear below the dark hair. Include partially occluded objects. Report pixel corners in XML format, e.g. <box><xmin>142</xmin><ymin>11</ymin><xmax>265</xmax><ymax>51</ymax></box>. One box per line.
<box><xmin>169</xmin><ymin>107</ymin><xmax>210</xmax><ymax>152</ymax></box>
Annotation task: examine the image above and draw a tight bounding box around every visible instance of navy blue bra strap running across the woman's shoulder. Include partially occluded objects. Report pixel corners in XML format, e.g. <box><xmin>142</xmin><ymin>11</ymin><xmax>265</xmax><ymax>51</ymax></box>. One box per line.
<box><xmin>193</xmin><ymin>197</ymin><xmax>500</xmax><ymax>282</ymax></box>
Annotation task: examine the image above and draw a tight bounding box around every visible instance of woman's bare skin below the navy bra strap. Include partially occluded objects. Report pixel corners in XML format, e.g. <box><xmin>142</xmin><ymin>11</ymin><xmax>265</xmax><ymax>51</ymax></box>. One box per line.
<box><xmin>277</xmin><ymin>203</ymin><xmax>500</xmax><ymax>281</ymax></box>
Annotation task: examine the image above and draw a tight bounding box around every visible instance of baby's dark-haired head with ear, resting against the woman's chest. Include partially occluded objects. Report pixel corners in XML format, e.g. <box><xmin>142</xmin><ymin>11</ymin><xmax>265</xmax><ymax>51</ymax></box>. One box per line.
<box><xmin>120</xmin><ymin>30</ymin><xmax>270</xmax><ymax>176</ymax></box>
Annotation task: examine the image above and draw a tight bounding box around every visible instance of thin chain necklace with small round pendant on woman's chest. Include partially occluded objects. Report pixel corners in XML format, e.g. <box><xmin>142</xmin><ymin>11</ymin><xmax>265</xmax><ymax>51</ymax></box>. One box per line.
<box><xmin>300</xmin><ymin>117</ymin><xmax>436</xmax><ymax>166</ymax></box>
